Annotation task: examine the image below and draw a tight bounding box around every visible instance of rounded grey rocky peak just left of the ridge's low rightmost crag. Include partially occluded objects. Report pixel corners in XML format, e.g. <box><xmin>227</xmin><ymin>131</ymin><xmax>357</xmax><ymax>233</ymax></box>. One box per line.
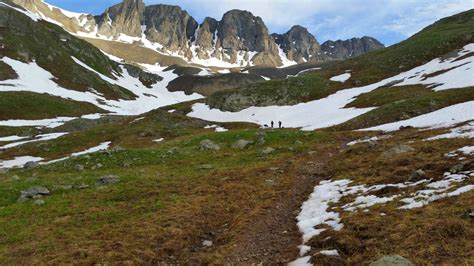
<box><xmin>272</xmin><ymin>25</ymin><xmax>321</xmax><ymax>63</ymax></box>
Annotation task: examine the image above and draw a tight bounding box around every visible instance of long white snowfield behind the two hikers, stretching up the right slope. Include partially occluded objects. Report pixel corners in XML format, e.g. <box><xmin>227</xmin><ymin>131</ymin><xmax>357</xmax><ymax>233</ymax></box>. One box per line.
<box><xmin>188</xmin><ymin>44</ymin><xmax>474</xmax><ymax>130</ymax></box>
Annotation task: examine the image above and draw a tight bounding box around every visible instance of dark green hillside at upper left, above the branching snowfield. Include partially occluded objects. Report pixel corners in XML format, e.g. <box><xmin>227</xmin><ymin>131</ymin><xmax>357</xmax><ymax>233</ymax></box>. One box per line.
<box><xmin>0</xmin><ymin>5</ymin><xmax>134</xmax><ymax>99</ymax></box>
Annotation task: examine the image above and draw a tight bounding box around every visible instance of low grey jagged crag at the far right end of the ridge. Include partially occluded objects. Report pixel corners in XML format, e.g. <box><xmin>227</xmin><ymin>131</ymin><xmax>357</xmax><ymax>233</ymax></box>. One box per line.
<box><xmin>321</xmin><ymin>36</ymin><xmax>385</xmax><ymax>59</ymax></box>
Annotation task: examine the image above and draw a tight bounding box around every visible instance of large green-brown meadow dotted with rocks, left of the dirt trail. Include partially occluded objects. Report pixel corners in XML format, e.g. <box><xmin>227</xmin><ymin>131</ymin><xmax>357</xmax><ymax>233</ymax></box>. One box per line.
<box><xmin>0</xmin><ymin>110</ymin><xmax>329</xmax><ymax>263</ymax></box>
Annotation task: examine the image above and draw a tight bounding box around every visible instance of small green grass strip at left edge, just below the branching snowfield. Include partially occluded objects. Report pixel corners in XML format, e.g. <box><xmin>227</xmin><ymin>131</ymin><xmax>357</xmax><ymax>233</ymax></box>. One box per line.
<box><xmin>0</xmin><ymin>92</ymin><xmax>105</xmax><ymax>120</ymax></box>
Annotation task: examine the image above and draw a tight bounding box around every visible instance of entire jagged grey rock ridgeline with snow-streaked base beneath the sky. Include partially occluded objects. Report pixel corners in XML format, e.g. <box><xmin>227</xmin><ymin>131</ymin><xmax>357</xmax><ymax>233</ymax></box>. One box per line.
<box><xmin>8</xmin><ymin>0</ymin><xmax>384</xmax><ymax>67</ymax></box>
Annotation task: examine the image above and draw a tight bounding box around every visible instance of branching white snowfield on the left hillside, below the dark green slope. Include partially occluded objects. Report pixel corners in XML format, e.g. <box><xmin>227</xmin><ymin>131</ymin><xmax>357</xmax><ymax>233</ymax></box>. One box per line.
<box><xmin>0</xmin><ymin>57</ymin><xmax>202</xmax><ymax>115</ymax></box>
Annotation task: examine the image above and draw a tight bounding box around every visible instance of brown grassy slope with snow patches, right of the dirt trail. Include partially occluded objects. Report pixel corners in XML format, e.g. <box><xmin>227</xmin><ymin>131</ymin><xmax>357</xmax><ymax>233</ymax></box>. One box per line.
<box><xmin>310</xmin><ymin>130</ymin><xmax>474</xmax><ymax>265</ymax></box>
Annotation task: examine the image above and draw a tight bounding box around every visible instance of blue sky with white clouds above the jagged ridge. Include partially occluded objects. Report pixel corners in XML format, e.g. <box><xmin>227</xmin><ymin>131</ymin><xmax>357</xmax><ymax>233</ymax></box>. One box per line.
<box><xmin>46</xmin><ymin>0</ymin><xmax>474</xmax><ymax>45</ymax></box>
